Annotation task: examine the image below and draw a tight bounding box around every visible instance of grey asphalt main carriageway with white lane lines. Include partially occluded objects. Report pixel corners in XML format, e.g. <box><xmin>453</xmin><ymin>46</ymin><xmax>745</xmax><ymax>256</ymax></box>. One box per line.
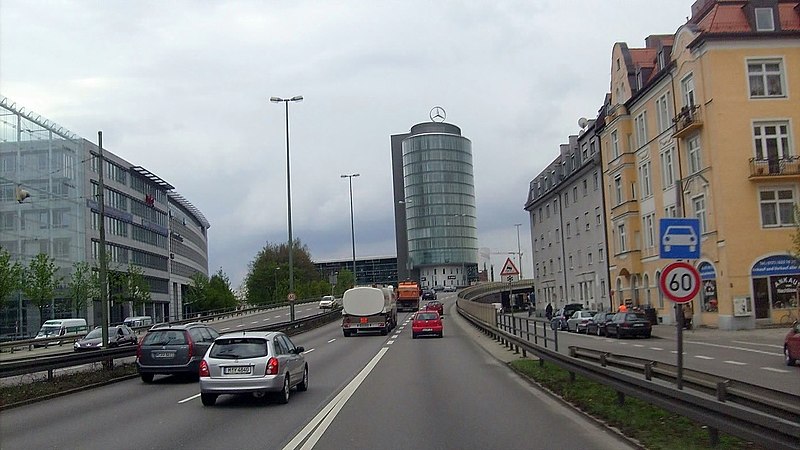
<box><xmin>0</xmin><ymin>296</ymin><xmax>631</xmax><ymax>450</ymax></box>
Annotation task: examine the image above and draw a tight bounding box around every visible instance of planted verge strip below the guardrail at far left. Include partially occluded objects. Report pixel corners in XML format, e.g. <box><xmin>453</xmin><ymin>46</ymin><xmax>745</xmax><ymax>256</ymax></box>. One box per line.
<box><xmin>0</xmin><ymin>363</ymin><xmax>137</xmax><ymax>409</ymax></box>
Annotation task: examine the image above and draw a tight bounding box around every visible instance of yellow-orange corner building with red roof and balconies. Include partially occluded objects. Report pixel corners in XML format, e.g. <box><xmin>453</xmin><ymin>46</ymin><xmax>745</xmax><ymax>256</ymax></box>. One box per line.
<box><xmin>601</xmin><ymin>0</ymin><xmax>800</xmax><ymax>329</ymax></box>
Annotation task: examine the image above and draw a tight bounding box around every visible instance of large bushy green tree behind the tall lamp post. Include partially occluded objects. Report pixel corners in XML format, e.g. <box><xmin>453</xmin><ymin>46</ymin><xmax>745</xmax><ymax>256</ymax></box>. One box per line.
<box><xmin>245</xmin><ymin>239</ymin><xmax>330</xmax><ymax>305</ymax></box>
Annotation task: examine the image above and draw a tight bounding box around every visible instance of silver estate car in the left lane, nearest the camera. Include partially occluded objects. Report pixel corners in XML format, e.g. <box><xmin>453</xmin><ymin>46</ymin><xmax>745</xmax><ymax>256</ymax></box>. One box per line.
<box><xmin>200</xmin><ymin>331</ymin><xmax>308</xmax><ymax>406</ymax></box>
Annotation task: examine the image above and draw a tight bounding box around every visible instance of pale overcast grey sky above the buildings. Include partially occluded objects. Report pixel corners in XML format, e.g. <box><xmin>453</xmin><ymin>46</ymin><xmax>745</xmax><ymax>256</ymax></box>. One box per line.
<box><xmin>0</xmin><ymin>0</ymin><xmax>692</xmax><ymax>288</ymax></box>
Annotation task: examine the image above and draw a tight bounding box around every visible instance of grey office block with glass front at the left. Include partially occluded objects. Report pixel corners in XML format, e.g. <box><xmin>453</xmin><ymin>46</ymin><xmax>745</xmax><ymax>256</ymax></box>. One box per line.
<box><xmin>0</xmin><ymin>98</ymin><xmax>210</xmax><ymax>335</ymax></box>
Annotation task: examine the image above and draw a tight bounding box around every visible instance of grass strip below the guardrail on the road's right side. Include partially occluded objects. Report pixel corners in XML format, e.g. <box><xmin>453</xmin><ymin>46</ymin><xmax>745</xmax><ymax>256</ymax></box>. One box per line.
<box><xmin>511</xmin><ymin>359</ymin><xmax>762</xmax><ymax>450</ymax></box>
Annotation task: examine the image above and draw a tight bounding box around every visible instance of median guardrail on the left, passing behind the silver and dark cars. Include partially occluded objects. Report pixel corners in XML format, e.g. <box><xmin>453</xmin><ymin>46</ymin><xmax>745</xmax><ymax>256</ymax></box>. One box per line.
<box><xmin>0</xmin><ymin>309</ymin><xmax>342</xmax><ymax>380</ymax></box>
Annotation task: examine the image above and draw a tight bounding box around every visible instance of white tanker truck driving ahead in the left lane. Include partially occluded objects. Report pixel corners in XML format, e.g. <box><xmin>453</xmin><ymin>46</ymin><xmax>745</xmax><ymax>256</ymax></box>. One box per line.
<box><xmin>342</xmin><ymin>286</ymin><xmax>397</xmax><ymax>337</ymax></box>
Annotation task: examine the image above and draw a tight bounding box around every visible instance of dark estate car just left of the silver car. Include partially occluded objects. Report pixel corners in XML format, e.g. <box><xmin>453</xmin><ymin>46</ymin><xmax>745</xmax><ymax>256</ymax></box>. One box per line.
<box><xmin>136</xmin><ymin>322</ymin><xmax>219</xmax><ymax>383</ymax></box>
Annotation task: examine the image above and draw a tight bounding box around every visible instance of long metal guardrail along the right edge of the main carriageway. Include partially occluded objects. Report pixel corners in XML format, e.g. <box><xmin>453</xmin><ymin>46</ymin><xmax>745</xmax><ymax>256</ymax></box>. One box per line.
<box><xmin>457</xmin><ymin>296</ymin><xmax>800</xmax><ymax>449</ymax></box>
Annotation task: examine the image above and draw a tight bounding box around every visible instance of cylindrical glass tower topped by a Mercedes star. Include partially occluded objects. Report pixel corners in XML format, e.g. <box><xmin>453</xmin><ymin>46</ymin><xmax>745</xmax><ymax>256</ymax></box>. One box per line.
<box><xmin>390</xmin><ymin>108</ymin><xmax>478</xmax><ymax>287</ymax></box>
